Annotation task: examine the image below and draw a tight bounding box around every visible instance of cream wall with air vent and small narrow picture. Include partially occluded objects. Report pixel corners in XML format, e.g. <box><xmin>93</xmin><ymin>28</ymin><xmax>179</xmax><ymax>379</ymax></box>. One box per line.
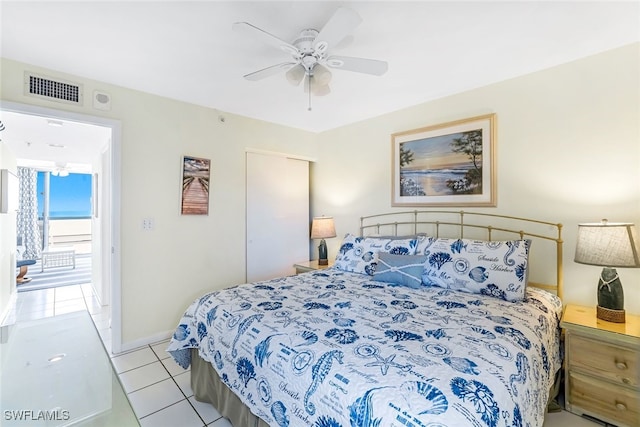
<box><xmin>0</xmin><ymin>59</ymin><xmax>315</xmax><ymax>349</ymax></box>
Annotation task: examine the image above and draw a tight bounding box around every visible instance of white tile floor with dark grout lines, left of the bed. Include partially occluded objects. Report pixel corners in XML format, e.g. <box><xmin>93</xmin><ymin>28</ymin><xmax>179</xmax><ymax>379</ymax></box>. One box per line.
<box><xmin>8</xmin><ymin>284</ymin><xmax>600</xmax><ymax>427</ymax></box>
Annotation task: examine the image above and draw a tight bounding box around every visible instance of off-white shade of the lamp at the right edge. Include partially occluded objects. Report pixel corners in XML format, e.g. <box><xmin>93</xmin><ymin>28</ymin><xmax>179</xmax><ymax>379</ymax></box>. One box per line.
<box><xmin>574</xmin><ymin>220</ymin><xmax>640</xmax><ymax>268</ymax></box>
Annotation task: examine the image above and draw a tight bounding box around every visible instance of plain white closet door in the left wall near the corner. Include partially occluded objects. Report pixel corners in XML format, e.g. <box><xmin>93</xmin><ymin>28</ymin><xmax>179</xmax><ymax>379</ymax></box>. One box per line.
<box><xmin>247</xmin><ymin>152</ymin><xmax>309</xmax><ymax>282</ymax></box>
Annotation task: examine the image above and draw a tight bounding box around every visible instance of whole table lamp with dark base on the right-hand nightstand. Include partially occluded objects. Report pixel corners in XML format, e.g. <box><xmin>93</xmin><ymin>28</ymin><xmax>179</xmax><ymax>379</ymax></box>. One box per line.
<box><xmin>574</xmin><ymin>219</ymin><xmax>640</xmax><ymax>323</ymax></box>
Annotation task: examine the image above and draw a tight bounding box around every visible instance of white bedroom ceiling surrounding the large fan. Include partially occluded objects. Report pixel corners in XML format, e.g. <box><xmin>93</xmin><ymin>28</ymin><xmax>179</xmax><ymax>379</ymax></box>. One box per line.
<box><xmin>0</xmin><ymin>0</ymin><xmax>640</xmax><ymax>166</ymax></box>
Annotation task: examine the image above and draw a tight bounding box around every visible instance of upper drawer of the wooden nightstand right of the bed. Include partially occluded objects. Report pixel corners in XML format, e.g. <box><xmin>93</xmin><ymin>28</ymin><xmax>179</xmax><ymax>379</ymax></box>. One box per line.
<box><xmin>569</xmin><ymin>334</ymin><xmax>640</xmax><ymax>388</ymax></box>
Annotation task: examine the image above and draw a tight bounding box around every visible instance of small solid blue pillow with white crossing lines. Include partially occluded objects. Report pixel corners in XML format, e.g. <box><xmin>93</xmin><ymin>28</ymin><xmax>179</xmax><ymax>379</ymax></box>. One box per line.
<box><xmin>373</xmin><ymin>252</ymin><xmax>427</xmax><ymax>289</ymax></box>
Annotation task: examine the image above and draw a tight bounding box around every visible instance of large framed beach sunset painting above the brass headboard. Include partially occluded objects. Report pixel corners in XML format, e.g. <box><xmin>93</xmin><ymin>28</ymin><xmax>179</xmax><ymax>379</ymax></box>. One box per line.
<box><xmin>391</xmin><ymin>114</ymin><xmax>496</xmax><ymax>206</ymax></box>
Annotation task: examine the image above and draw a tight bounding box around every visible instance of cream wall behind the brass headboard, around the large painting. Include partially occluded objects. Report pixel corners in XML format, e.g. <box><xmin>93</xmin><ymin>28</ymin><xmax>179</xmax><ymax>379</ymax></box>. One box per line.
<box><xmin>312</xmin><ymin>43</ymin><xmax>640</xmax><ymax>313</ymax></box>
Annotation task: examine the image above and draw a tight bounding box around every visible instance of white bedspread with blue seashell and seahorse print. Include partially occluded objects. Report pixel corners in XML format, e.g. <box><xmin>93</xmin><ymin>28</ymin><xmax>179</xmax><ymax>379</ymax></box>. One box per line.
<box><xmin>167</xmin><ymin>268</ymin><xmax>562</xmax><ymax>427</ymax></box>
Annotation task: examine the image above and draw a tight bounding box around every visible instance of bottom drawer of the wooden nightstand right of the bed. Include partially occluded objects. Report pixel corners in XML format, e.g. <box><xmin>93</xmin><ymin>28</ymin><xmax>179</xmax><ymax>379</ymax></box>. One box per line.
<box><xmin>569</xmin><ymin>371</ymin><xmax>640</xmax><ymax>426</ymax></box>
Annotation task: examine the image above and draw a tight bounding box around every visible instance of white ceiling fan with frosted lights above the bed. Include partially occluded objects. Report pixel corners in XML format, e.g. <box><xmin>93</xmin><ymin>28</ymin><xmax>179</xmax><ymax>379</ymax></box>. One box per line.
<box><xmin>233</xmin><ymin>7</ymin><xmax>388</xmax><ymax>110</ymax></box>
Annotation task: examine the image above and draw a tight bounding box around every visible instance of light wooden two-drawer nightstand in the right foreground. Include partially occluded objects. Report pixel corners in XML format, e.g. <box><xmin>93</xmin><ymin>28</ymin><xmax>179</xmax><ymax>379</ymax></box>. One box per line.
<box><xmin>560</xmin><ymin>305</ymin><xmax>640</xmax><ymax>427</ymax></box>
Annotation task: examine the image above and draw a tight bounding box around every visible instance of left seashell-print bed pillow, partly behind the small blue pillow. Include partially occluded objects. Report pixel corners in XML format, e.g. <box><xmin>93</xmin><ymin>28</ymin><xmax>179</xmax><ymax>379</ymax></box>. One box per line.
<box><xmin>334</xmin><ymin>234</ymin><xmax>417</xmax><ymax>276</ymax></box>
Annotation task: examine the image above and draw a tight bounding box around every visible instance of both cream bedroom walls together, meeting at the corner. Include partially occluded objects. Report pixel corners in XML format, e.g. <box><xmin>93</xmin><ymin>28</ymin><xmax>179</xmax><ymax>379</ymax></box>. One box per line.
<box><xmin>0</xmin><ymin>44</ymin><xmax>640</xmax><ymax>347</ymax></box>
